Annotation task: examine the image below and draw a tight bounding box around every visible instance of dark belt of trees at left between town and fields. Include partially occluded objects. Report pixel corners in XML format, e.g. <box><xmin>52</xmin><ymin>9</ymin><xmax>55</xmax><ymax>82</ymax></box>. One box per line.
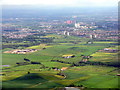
<box><xmin>2</xmin><ymin>34</ymin><xmax>54</xmax><ymax>49</ymax></box>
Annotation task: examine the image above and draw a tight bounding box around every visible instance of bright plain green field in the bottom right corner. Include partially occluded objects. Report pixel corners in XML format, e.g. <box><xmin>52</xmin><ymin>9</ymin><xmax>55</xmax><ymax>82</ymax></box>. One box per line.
<box><xmin>75</xmin><ymin>75</ymin><xmax>120</xmax><ymax>88</ymax></box>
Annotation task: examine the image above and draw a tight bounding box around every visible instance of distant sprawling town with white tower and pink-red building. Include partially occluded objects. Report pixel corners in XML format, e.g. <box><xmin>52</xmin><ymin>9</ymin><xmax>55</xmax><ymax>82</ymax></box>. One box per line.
<box><xmin>2</xmin><ymin>16</ymin><xmax>120</xmax><ymax>39</ymax></box>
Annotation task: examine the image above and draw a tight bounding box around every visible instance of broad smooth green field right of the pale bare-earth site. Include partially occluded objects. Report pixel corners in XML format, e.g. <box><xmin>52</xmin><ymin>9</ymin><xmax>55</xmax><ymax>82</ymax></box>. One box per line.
<box><xmin>32</xmin><ymin>44</ymin><xmax>105</xmax><ymax>56</ymax></box>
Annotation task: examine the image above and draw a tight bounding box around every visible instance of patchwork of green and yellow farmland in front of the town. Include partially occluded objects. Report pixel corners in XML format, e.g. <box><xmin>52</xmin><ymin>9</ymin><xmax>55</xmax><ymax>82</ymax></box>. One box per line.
<box><xmin>0</xmin><ymin>35</ymin><xmax>119</xmax><ymax>89</ymax></box>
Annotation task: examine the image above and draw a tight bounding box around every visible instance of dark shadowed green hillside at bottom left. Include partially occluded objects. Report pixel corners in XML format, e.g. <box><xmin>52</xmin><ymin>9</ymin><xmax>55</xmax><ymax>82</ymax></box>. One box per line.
<box><xmin>3</xmin><ymin>73</ymin><xmax>54</xmax><ymax>88</ymax></box>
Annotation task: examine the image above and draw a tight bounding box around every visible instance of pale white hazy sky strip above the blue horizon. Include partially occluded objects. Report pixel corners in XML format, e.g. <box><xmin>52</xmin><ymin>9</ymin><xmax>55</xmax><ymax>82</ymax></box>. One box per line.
<box><xmin>0</xmin><ymin>0</ymin><xmax>119</xmax><ymax>7</ymax></box>
